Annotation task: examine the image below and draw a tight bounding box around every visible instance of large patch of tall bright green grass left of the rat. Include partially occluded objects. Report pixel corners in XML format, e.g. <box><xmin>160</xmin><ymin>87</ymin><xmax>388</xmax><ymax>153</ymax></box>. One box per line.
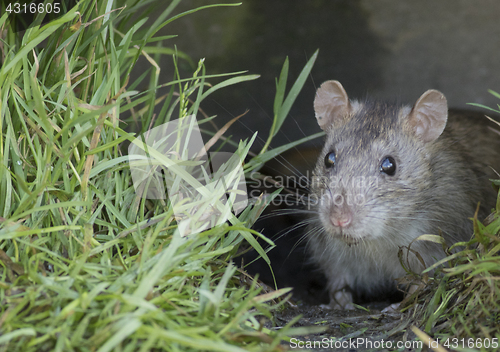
<box><xmin>0</xmin><ymin>0</ymin><xmax>317</xmax><ymax>352</ymax></box>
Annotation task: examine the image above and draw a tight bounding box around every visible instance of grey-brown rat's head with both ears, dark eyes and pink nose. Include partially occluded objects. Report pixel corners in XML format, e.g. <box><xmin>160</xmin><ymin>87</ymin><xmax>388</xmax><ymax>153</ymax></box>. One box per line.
<box><xmin>312</xmin><ymin>81</ymin><xmax>448</xmax><ymax>245</ymax></box>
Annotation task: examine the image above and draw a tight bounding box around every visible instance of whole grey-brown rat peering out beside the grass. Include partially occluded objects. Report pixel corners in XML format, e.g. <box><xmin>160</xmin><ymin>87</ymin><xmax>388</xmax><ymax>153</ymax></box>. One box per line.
<box><xmin>308</xmin><ymin>81</ymin><xmax>500</xmax><ymax>308</ymax></box>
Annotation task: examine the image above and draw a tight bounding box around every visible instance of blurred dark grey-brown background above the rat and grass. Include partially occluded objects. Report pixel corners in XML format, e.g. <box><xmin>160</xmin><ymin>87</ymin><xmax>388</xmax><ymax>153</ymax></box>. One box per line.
<box><xmin>160</xmin><ymin>0</ymin><xmax>500</xmax><ymax>150</ymax></box>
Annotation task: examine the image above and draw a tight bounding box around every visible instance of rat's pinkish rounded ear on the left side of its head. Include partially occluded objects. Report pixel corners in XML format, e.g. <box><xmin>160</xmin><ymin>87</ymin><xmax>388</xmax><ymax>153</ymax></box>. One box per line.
<box><xmin>314</xmin><ymin>81</ymin><xmax>351</xmax><ymax>130</ymax></box>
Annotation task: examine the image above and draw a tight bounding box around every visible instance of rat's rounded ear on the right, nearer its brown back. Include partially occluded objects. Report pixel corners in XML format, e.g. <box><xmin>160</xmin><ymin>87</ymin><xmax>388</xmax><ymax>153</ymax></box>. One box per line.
<box><xmin>408</xmin><ymin>89</ymin><xmax>448</xmax><ymax>143</ymax></box>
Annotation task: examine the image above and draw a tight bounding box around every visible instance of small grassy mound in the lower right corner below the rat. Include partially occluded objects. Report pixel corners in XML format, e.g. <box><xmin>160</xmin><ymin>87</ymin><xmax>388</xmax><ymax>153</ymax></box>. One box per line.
<box><xmin>405</xmin><ymin>106</ymin><xmax>500</xmax><ymax>351</ymax></box>
